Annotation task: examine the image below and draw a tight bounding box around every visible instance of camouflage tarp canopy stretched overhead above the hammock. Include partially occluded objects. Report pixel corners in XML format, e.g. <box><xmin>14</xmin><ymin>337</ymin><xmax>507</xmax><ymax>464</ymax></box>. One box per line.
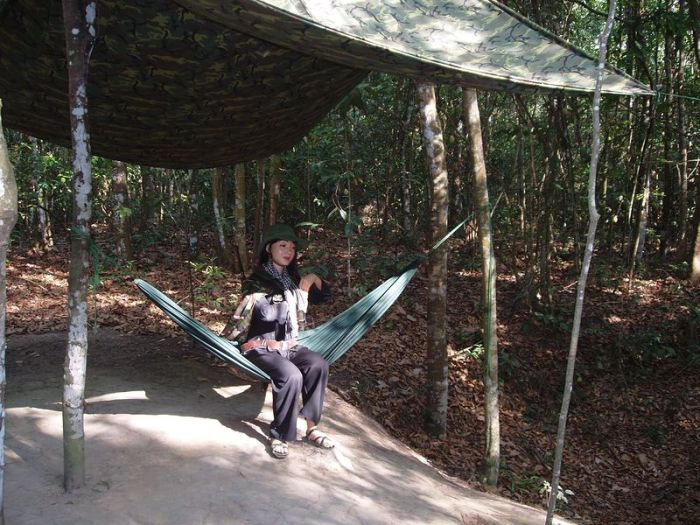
<box><xmin>0</xmin><ymin>0</ymin><xmax>650</xmax><ymax>167</ymax></box>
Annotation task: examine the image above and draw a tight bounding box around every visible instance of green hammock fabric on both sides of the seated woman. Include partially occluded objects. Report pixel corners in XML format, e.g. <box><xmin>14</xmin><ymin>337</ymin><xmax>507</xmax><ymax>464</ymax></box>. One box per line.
<box><xmin>135</xmin><ymin>261</ymin><xmax>418</xmax><ymax>382</ymax></box>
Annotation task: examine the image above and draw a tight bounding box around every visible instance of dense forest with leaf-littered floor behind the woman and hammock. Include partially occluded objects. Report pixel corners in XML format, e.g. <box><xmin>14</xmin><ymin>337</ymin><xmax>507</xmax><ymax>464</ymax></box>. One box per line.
<box><xmin>6</xmin><ymin>0</ymin><xmax>700</xmax><ymax>523</ymax></box>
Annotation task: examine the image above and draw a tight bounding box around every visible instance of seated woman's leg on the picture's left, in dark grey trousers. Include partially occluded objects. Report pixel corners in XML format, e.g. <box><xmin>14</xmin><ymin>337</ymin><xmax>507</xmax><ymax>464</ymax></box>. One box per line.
<box><xmin>246</xmin><ymin>350</ymin><xmax>303</xmax><ymax>441</ymax></box>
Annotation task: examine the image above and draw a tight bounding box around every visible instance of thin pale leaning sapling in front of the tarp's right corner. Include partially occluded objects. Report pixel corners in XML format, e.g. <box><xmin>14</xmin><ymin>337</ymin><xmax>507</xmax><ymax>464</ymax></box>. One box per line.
<box><xmin>546</xmin><ymin>0</ymin><xmax>617</xmax><ymax>525</ymax></box>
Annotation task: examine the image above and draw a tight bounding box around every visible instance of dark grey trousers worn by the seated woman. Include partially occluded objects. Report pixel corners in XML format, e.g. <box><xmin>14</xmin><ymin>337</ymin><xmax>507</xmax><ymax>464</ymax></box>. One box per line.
<box><xmin>245</xmin><ymin>345</ymin><xmax>328</xmax><ymax>441</ymax></box>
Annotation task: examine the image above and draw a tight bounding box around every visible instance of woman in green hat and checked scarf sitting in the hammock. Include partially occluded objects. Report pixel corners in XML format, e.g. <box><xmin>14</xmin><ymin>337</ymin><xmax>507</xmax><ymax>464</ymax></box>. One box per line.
<box><xmin>222</xmin><ymin>224</ymin><xmax>334</xmax><ymax>458</ymax></box>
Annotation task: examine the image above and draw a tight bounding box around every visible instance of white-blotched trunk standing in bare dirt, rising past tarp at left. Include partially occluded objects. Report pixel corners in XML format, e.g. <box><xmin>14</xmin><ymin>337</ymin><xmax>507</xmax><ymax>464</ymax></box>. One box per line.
<box><xmin>63</xmin><ymin>0</ymin><xmax>97</xmax><ymax>492</ymax></box>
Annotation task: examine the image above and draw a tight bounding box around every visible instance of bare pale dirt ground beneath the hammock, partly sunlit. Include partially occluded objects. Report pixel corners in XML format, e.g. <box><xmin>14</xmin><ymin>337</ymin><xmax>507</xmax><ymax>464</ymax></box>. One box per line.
<box><xmin>5</xmin><ymin>328</ymin><xmax>576</xmax><ymax>525</ymax></box>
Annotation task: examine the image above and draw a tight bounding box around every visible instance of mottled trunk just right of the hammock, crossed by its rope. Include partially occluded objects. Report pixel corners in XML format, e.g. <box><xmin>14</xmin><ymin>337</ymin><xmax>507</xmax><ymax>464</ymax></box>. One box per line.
<box><xmin>417</xmin><ymin>83</ymin><xmax>450</xmax><ymax>439</ymax></box>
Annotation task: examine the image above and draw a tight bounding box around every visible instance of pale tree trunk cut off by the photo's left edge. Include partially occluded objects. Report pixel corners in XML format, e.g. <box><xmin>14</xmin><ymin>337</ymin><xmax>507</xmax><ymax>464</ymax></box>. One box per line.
<box><xmin>0</xmin><ymin>99</ymin><xmax>17</xmax><ymax>525</ymax></box>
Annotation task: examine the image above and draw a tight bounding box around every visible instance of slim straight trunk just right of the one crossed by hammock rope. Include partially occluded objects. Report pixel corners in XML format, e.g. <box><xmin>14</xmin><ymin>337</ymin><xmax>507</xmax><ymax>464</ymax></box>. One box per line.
<box><xmin>464</xmin><ymin>88</ymin><xmax>501</xmax><ymax>486</ymax></box>
